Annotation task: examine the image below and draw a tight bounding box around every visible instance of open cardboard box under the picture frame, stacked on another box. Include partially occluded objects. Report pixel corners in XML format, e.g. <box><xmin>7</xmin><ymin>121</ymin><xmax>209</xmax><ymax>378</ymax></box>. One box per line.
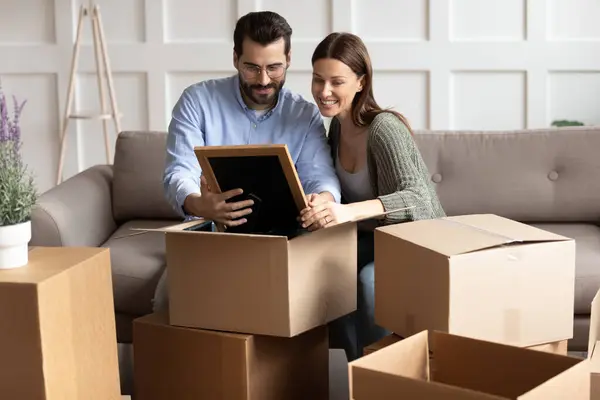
<box><xmin>142</xmin><ymin>221</ymin><xmax>357</xmax><ymax>337</ymax></box>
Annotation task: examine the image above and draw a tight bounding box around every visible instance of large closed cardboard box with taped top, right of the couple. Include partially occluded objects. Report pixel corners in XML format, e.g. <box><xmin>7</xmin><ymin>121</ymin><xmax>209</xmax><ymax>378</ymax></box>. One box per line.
<box><xmin>375</xmin><ymin>214</ymin><xmax>575</xmax><ymax>347</ymax></box>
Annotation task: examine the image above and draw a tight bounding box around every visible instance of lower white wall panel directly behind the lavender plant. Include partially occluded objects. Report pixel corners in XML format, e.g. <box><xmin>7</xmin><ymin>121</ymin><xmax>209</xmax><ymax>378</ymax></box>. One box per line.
<box><xmin>0</xmin><ymin>73</ymin><xmax>58</xmax><ymax>192</ymax></box>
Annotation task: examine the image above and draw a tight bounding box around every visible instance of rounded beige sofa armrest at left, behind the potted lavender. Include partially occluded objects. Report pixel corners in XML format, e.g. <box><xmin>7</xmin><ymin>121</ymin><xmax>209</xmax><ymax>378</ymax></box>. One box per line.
<box><xmin>29</xmin><ymin>165</ymin><xmax>117</xmax><ymax>247</ymax></box>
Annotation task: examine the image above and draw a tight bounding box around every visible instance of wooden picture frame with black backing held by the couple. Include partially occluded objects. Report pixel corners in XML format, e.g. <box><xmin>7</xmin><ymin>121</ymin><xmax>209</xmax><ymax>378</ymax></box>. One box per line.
<box><xmin>194</xmin><ymin>144</ymin><xmax>308</xmax><ymax>234</ymax></box>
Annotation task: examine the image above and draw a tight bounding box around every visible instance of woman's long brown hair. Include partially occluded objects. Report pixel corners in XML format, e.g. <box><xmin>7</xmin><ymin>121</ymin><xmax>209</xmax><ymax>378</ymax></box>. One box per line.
<box><xmin>311</xmin><ymin>32</ymin><xmax>413</xmax><ymax>135</ymax></box>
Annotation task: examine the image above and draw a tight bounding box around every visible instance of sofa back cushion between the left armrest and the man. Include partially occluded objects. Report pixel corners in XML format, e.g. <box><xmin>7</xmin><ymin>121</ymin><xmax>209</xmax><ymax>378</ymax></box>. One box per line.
<box><xmin>112</xmin><ymin>132</ymin><xmax>179</xmax><ymax>223</ymax></box>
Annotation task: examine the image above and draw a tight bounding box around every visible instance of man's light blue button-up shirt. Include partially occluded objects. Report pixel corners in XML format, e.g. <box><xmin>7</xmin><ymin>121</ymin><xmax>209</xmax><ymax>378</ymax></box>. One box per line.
<box><xmin>163</xmin><ymin>75</ymin><xmax>341</xmax><ymax>217</ymax></box>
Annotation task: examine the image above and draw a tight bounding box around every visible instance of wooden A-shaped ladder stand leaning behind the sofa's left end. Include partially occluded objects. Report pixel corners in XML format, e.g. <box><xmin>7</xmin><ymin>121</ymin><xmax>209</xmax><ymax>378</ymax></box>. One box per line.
<box><xmin>56</xmin><ymin>0</ymin><xmax>121</xmax><ymax>185</ymax></box>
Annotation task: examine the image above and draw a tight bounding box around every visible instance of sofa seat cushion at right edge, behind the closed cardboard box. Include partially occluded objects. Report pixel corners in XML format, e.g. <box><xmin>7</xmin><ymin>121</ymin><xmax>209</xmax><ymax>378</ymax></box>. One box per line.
<box><xmin>532</xmin><ymin>223</ymin><xmax>600</xmax><ymax>314</ymax></box>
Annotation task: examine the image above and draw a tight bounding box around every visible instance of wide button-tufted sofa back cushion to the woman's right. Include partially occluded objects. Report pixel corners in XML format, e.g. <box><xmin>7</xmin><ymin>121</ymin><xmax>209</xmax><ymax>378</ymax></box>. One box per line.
<box><xmin>415</xmin><ymin>127</ymin><xmax>600</xmax><ymax>222</ymax></box>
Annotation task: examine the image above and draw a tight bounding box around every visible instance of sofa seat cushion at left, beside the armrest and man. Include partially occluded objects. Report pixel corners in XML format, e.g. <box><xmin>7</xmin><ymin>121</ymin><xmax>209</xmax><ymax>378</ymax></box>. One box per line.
<box><xmin>102</xmin><ymin>220</ymin><xmax>174</xmax><ymax>316</ymax></box>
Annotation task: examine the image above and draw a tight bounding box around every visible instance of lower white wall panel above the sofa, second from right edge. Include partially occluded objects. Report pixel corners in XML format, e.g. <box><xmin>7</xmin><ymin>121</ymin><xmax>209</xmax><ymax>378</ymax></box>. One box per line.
<box><xmin>451</xmin><ymin>71</ymin><xmax>526</xmax><ymax>129</ymax></box>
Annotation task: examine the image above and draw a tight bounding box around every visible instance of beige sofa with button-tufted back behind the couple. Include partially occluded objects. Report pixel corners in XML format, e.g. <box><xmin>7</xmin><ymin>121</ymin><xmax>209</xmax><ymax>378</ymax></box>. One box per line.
<box><xmin>31</xmin><ymin>127</ymin><xmax>600</xmax><ymax>350</ymax></box>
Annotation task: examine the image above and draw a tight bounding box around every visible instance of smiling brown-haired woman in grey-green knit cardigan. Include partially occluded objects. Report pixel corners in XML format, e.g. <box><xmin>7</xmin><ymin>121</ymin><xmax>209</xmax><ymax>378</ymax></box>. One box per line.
<box><xmin>300</xmin><ymin>33</ymin><xmax>445</xmax><ymax>361</ymax></box>
